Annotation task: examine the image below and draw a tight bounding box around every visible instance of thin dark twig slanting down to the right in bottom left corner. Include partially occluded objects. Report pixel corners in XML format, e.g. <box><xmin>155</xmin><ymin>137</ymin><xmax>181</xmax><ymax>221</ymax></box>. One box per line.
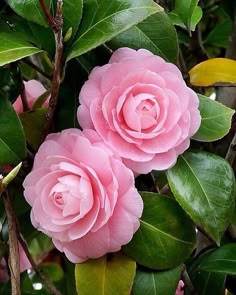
<box><xmin>18</xmin><ymin>233</ymin><xmax>62</xmax><ymax>295</ymax></box>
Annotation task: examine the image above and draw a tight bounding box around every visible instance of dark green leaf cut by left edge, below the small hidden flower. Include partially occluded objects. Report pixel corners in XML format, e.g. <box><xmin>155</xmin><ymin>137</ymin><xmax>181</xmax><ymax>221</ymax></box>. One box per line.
<box><xmin>0</xmin><ymin>97</ymin><xmax>26</xmax><ymax>165</ymax></box>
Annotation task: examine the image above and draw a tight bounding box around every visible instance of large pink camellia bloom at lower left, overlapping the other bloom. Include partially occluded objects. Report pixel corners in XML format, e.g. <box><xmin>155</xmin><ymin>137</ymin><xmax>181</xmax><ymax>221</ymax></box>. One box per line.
<box><xmin>23</xmin><ymin>129</ymin><xmax>143</xmax><ymax>263</ymax></box>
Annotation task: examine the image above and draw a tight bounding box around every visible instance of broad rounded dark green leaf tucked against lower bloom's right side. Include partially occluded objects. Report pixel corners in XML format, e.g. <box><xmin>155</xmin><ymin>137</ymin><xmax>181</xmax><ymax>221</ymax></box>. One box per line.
<box><xmin>123</xmin><ymin>192</ymin><xmax>196</xmax><ymax>269</ymax></box>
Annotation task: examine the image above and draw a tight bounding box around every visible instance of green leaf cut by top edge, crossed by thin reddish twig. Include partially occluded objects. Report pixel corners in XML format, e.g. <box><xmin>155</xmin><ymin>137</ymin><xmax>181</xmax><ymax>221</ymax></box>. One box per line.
<box><xmin>6</xmin><ymin>0</ymin><xmax>51</xmax><ymax>27</ymax></box>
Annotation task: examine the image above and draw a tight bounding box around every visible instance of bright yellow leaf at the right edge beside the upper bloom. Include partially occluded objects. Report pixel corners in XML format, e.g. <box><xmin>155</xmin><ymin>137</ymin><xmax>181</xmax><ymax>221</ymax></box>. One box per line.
<box><xmin>189</xmin><ymin>58</ymin><xmax>236</xmax><ymax>86</ymax></box>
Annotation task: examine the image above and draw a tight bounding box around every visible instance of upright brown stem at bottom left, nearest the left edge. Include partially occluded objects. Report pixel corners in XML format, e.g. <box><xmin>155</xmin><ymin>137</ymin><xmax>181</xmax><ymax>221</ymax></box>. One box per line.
<box><xmin>2</xmin><ymin>190</ymin><xmax>21</xmax><ymax>295</ymax></box>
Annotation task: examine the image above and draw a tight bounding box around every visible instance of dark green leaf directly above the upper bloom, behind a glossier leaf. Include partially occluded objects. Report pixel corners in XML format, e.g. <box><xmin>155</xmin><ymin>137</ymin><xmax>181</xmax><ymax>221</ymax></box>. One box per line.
<box><xmin>109</xmin><ymin>11</ymin><xmax>178</xmax><ymax>62</ymax></box>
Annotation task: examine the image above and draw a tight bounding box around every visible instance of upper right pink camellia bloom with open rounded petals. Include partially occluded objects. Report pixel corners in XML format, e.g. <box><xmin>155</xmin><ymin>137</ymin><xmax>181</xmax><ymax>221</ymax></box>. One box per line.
<box><xmin>78</xmin><ymin>48</ymin><xmax>201</xmax><ymax>174</ymax></box>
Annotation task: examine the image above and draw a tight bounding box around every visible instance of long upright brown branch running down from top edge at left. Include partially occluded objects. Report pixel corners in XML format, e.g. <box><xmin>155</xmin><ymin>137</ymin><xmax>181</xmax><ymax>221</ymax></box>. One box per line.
<box><xmin>42</xmin><ymin>0</ymin><xmax>63</xmax><ymax>141</ymax></box>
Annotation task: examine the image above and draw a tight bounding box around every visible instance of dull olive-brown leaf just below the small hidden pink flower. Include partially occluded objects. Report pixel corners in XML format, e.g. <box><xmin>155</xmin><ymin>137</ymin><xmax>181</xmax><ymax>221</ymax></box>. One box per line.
<box><xmin>20</xmin><ymin>108</ymin><xmax>47</xmax><ymax>151</ymax></box>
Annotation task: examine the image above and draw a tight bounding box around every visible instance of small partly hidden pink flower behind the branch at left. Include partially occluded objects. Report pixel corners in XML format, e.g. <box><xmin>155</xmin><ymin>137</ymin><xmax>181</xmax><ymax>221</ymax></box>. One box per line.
<box><xmin>13</xmin><ymin>80</ymin><xmax>48</xmax><ymax>114</ymax></box>
